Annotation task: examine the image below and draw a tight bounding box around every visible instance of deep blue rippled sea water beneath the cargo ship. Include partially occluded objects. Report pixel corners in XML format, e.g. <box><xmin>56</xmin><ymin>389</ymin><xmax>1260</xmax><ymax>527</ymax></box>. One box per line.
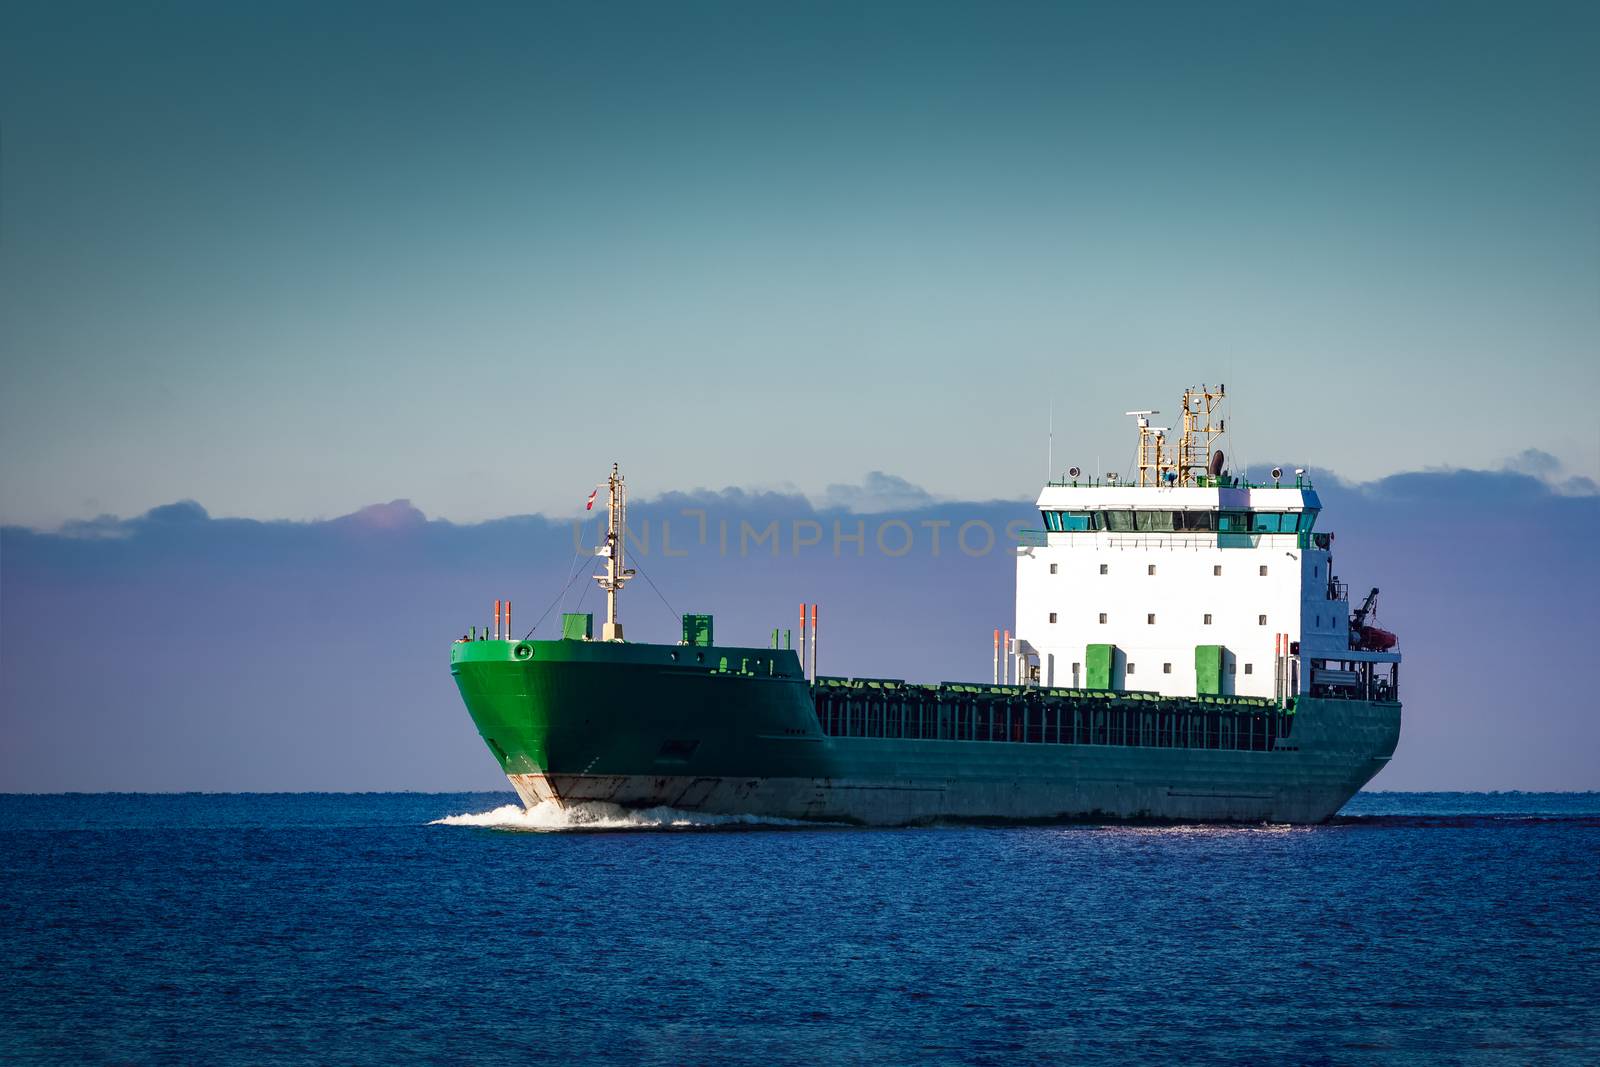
<box><xmin>0</xmin><ymin>793</ymin><xmax>1600</xmax><ymax>1064</ymax></box>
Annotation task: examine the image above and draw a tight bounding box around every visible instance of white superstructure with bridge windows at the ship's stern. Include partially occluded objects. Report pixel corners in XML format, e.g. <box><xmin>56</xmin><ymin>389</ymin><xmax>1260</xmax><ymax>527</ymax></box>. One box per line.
<box><xmin>1008</xmin><ymin>383</ymin><xmax>1400</xmax><ymax>699</ymax></box>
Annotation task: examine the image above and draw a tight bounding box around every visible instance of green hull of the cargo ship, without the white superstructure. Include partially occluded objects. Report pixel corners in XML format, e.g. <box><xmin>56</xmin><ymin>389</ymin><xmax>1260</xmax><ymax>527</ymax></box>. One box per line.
<box><xmin>451</xmin><ymin>640</ymin><xmax>1400</xmax><ymax>825</ymax></box>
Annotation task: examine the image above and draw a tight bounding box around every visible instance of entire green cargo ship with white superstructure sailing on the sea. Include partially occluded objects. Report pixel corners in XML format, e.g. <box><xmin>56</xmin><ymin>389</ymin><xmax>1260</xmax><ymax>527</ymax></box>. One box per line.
<box><xmin>451</xmin><ymin>389</ymin><xmax>1400</xmax><ymax>825</ymax></box>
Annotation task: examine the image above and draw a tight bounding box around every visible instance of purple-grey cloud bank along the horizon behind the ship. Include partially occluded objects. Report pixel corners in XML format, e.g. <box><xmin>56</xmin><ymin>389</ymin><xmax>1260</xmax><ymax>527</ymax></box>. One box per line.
<box><xmin>0</xmin><ymin>461</ymin><xmax>1600</xmax><ymax>790</ymax></box>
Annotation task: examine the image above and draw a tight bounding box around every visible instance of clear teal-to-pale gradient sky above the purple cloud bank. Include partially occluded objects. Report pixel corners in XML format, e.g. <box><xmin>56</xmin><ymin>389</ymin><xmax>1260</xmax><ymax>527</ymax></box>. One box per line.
<box><xmin>0</xmin><ymin>2</ymin><xmax>1600</xmax><ymax>525</ymax></box>
